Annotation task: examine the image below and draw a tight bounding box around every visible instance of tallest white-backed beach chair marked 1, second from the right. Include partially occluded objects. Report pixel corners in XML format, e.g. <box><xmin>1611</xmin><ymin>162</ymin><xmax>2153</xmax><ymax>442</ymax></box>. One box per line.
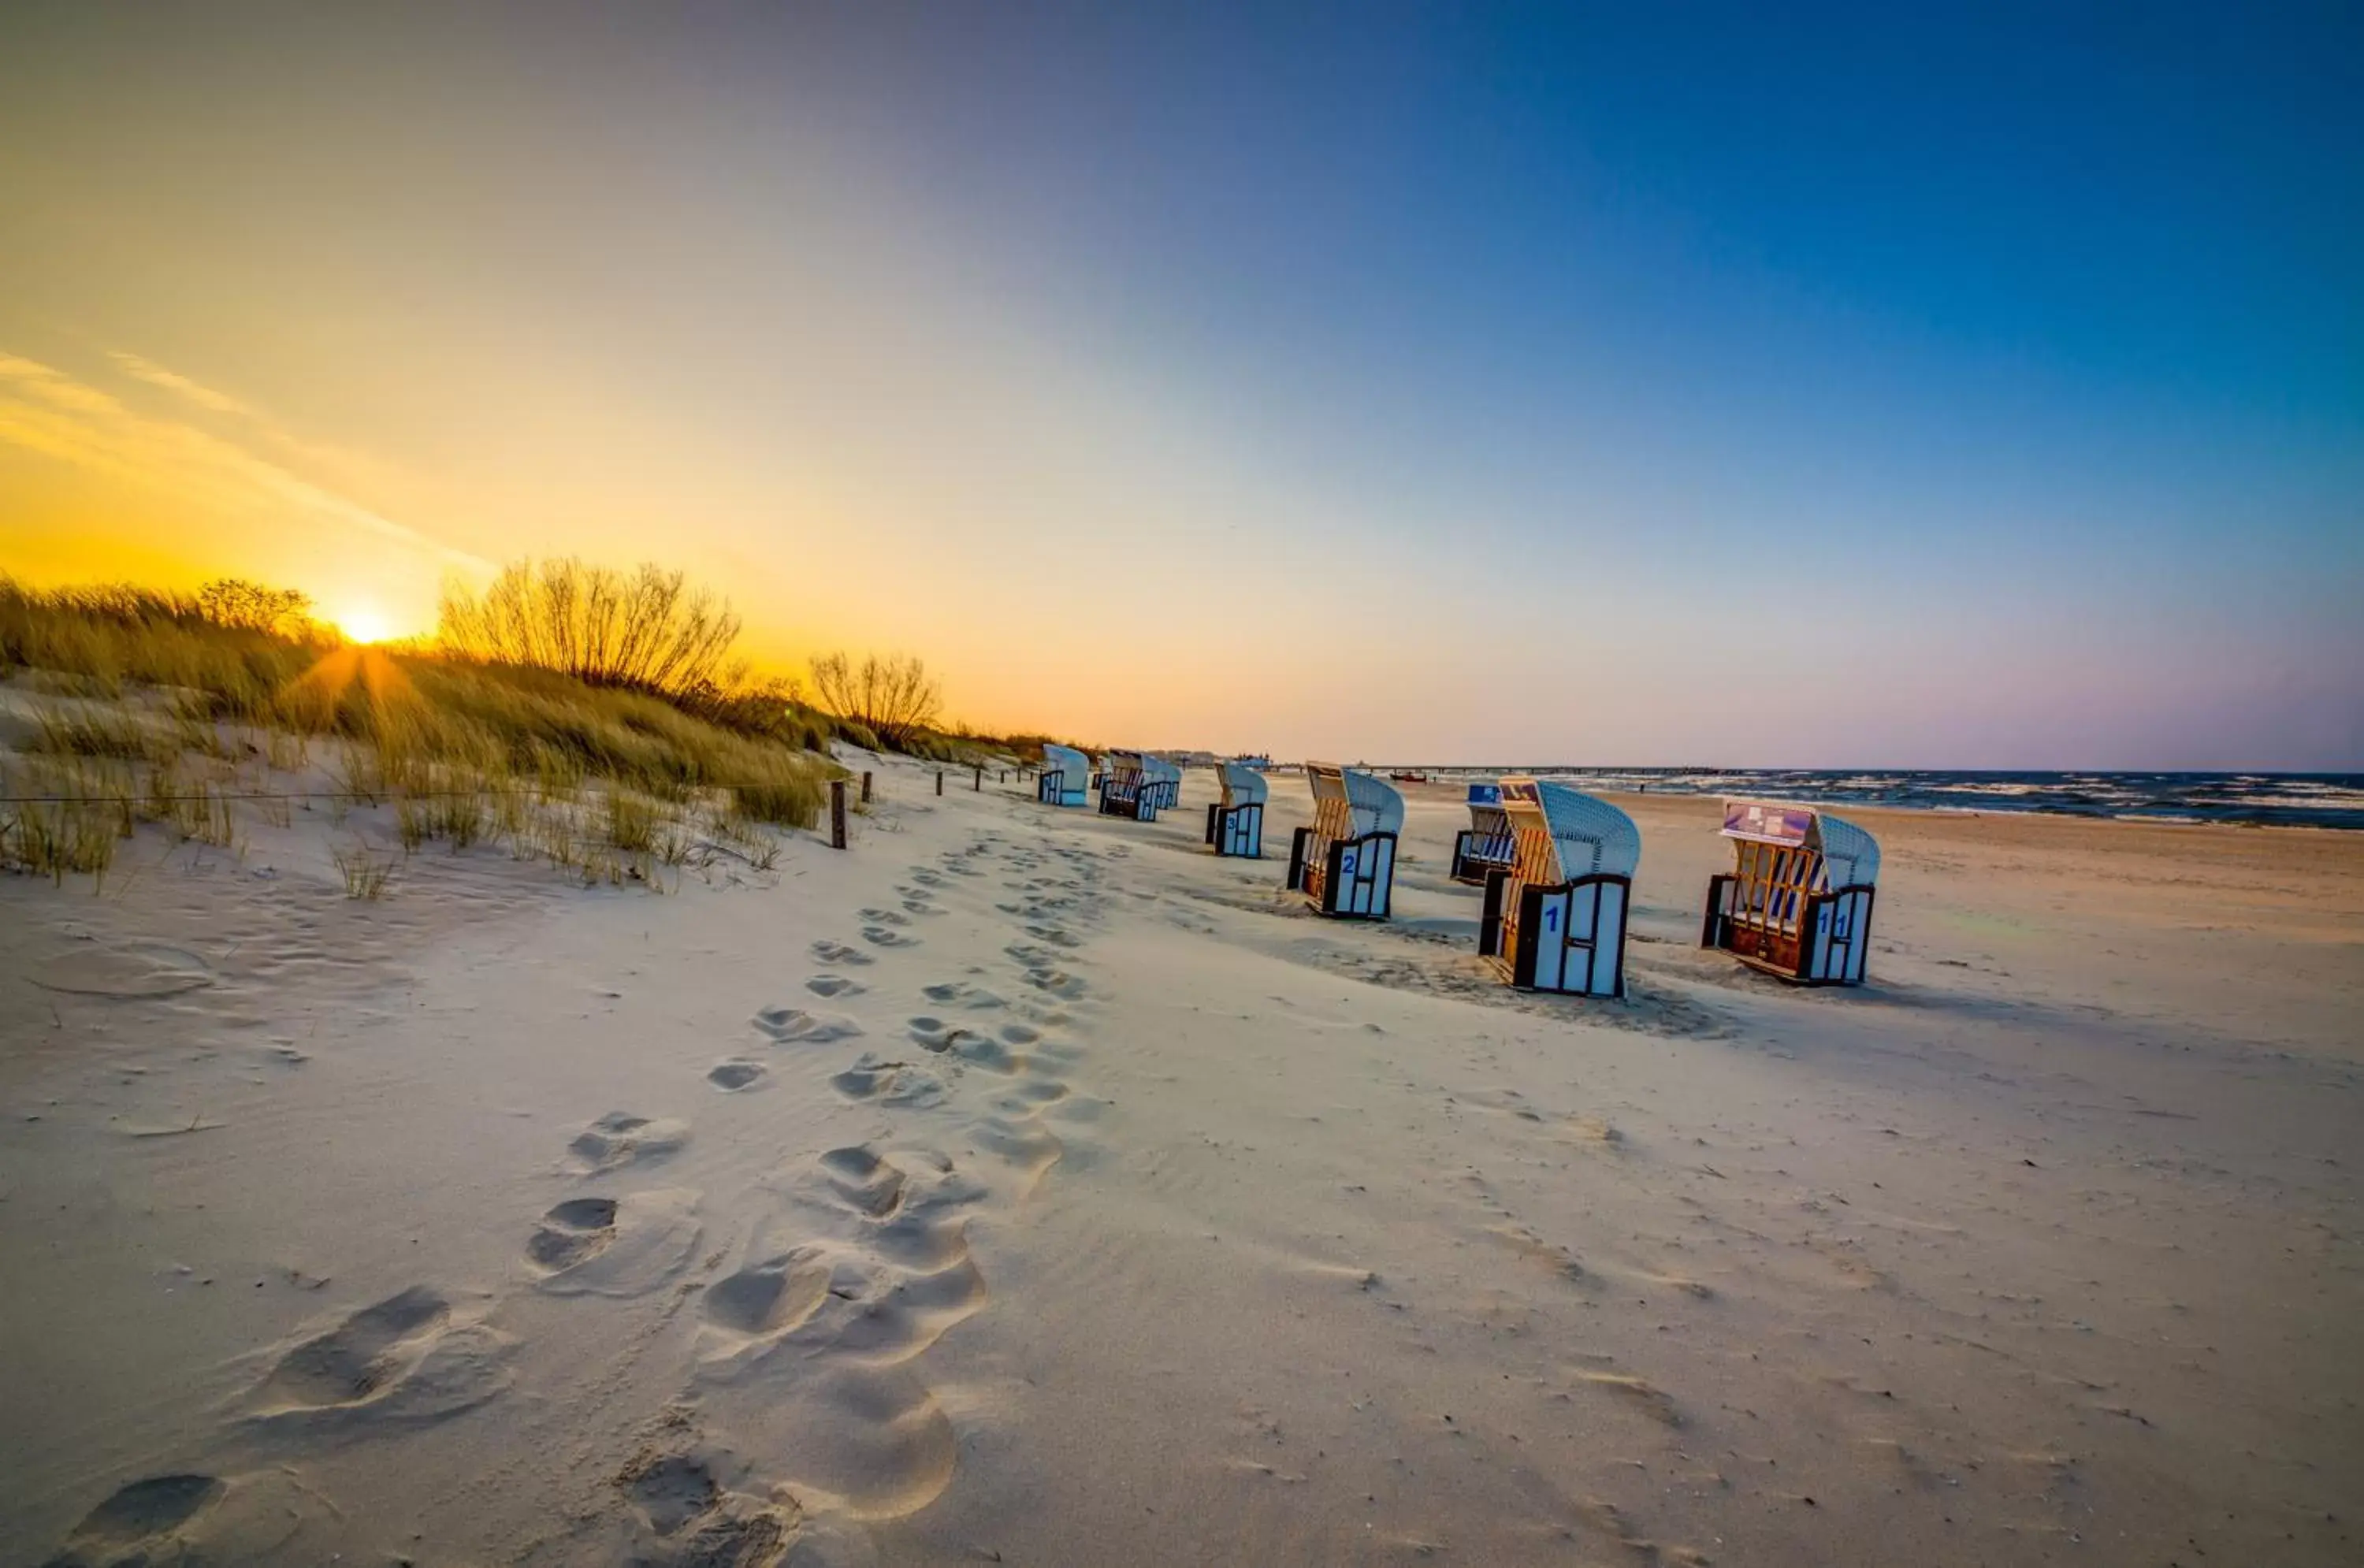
<box><xmin>1478</xmin><ymin>778</ymin><xmax>1641</xmax><ymax>996</ymax></box>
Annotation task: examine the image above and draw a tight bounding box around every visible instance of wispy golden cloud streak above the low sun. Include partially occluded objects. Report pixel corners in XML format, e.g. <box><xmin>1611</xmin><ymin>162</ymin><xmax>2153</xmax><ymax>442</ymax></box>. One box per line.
<box><xmin>0</xmin><ymin>350</ymin><xmax>492</xmax><ymax>572</ymax></box>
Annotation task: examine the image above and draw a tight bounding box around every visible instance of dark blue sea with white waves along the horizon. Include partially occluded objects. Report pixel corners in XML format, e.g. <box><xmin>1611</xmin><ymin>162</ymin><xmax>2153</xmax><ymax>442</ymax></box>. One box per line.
<box><xmin>1390</xmin><ymin>764</ymin><xmax>2364</xmax><ymax>830</ymax></box>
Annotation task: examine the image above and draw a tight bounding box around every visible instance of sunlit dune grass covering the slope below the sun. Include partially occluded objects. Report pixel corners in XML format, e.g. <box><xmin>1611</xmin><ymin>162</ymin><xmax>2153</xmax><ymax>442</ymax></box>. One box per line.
<box><xmin>0</xmin><ymin>577</ymin><xmax>837</xmax><ymax>897</ymax></box>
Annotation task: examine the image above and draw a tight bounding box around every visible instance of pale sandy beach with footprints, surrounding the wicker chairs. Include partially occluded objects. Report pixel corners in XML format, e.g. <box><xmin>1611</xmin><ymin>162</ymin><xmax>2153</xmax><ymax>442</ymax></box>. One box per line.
<box><xmin>0</xmin><ymin>761</ymin><xmax>2364</xmax><ymax>1568</ymax></box>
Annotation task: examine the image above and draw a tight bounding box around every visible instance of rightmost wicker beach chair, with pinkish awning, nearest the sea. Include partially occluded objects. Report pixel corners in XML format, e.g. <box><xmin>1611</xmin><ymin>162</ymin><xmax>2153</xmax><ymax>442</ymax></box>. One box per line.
<box><xmin>1700</xmin><ymin>800</ymin><xmax>1879</xmax><ymax>987</ymax></box>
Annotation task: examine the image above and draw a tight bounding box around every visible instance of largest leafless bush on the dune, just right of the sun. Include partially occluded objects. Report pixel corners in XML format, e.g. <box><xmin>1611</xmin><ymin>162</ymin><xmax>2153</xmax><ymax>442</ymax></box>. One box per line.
<box><xmin>435</xmin><ymin>558</ymin><xmax>740</xmax><ymax>695</ymax></box>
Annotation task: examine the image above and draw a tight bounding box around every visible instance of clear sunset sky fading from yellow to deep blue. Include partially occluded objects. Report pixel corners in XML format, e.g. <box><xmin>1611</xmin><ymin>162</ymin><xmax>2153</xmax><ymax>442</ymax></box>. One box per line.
<box><xmin>0</xmin><ymin>0</ymin><xmax>2364</xmax><ymax>771</ymax></box>
